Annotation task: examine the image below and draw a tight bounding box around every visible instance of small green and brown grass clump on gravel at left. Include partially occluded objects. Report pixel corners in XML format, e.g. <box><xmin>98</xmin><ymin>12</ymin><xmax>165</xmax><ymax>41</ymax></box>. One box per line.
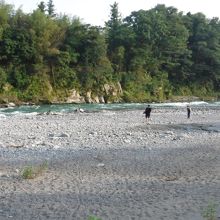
<box><xmin>21</xmin><ymin>161</ymin><xmax>48</xmax><ymax>179</ymax></box>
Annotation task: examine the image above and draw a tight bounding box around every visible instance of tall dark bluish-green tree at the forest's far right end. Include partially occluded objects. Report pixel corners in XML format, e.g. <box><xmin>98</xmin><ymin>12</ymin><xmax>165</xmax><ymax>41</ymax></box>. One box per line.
<box><xmin>185</xmin><ymin>13</ymin><xmax>220</xmax><ymax>92</ymax></box>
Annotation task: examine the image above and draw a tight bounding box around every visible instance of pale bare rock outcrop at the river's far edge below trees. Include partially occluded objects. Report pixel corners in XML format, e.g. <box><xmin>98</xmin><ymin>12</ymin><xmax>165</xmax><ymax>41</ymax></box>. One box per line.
<box><xmin>66</xmin><ymin>82</ymin><xmax>123</xmax><ymax>103</ymax></box>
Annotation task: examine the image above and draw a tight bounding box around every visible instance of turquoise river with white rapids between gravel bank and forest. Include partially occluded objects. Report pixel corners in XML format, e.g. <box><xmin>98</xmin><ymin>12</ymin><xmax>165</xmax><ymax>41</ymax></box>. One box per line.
<box><xmin>0</xmin><ymin>101</ymin><xmax>220</xmax><ymax>115</ymax></box>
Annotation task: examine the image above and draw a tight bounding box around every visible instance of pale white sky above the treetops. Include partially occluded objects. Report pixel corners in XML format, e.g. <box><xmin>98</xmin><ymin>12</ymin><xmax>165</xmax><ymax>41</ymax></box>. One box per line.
<box><xmin>5</xmin><ymin>0</ymin><xmax>220</xmax><ymax>26</ymax></box>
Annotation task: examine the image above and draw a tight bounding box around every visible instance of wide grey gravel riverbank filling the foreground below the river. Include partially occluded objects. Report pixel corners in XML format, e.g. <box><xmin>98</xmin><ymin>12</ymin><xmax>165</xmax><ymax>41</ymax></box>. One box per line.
<box><xmin>0</xmin><ymin>109</ymin><xmax>220</xmax><ymax>220</ymax></box>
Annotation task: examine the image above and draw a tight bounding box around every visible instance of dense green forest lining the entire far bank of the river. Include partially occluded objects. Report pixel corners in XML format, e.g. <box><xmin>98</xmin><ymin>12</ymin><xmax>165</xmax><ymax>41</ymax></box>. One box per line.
<box><xmin>0</xmin><ymin>0</ymin><xmax>220</xmax><ymax>103</ymax></box>
